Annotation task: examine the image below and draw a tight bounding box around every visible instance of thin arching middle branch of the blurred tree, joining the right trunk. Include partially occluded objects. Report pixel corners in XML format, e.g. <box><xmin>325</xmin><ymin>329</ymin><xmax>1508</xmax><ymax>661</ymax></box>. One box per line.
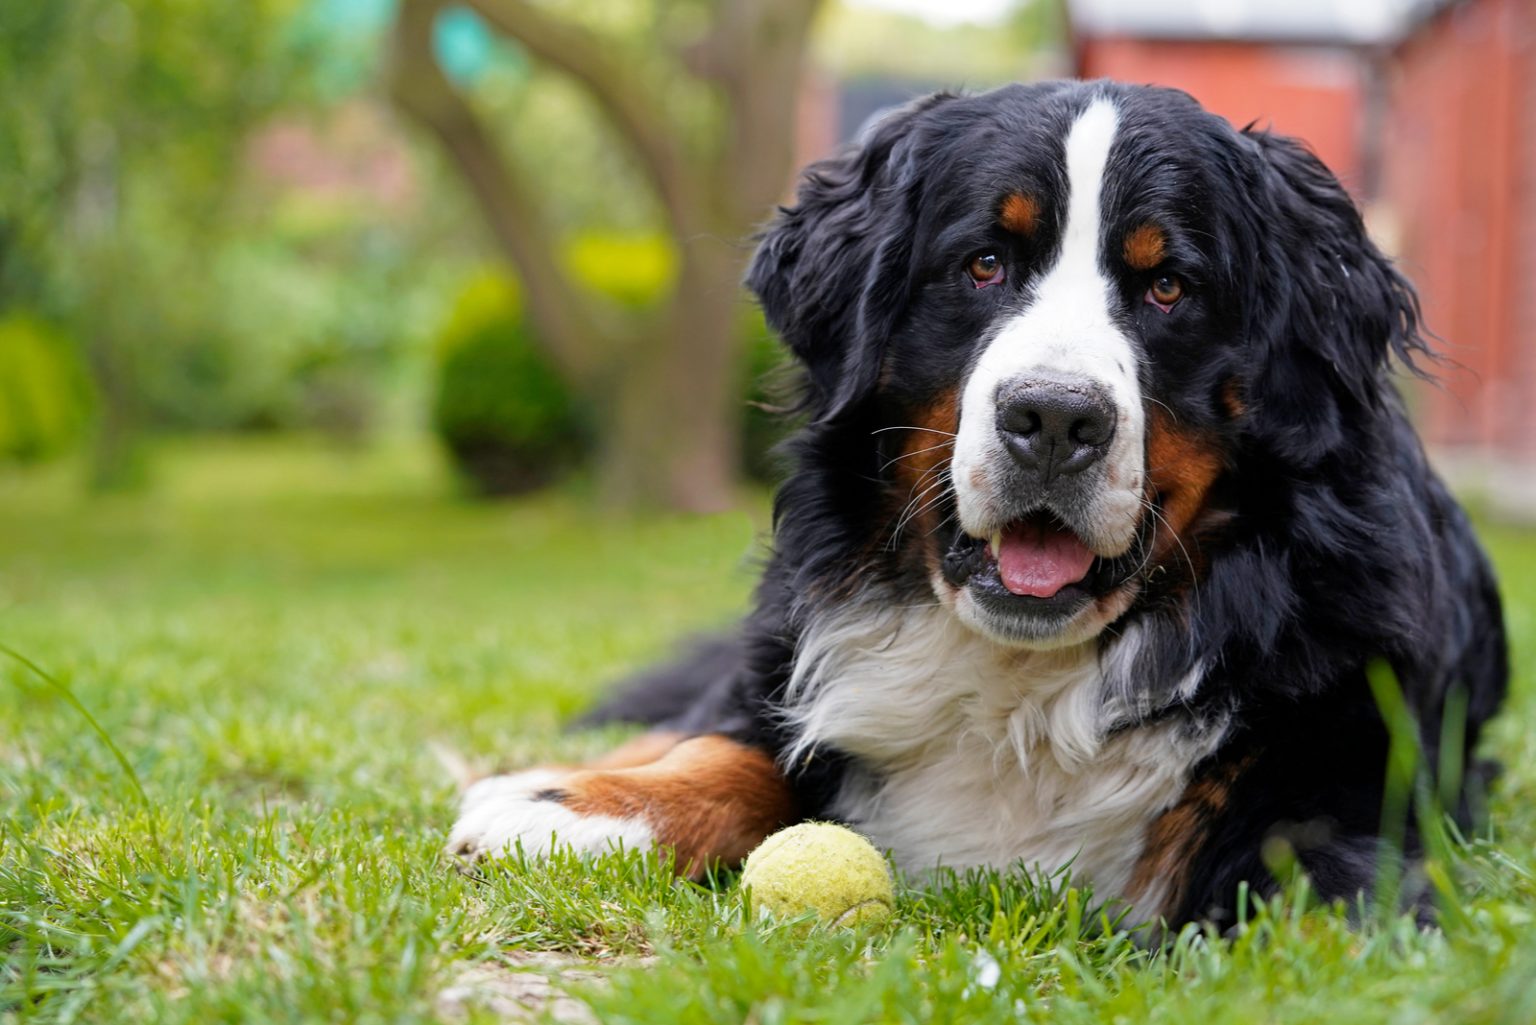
<box><xmin>468</xmin><ymin>0</ymin><xmax>699</xmax><ymax>234</ymax></box>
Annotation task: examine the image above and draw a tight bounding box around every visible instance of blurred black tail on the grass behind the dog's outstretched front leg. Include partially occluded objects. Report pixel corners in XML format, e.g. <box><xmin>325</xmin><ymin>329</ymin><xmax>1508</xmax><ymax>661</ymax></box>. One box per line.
<box><xmin>570</xmin><ymin>627</ymin><xmax>746</xmax><ymax>731</ymax></box>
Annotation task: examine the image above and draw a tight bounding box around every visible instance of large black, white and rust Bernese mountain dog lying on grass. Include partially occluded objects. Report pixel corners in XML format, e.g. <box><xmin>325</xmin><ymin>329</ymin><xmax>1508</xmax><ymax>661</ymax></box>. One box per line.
<box><xmin>450</xmin><ymin>81</ymin><xmax>1507</xmax><ymax>925</ymax></box>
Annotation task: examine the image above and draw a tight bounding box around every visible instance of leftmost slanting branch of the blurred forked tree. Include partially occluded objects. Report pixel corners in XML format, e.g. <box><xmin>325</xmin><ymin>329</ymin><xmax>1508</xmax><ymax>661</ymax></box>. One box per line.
<box><xmin>390</xmin><ymin>0</ymin><xmax>610</xmax><ymax>381</ymax></box>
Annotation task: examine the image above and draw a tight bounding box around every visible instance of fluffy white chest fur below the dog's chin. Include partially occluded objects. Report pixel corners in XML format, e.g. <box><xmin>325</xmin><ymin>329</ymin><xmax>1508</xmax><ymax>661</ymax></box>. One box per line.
<box><xmin>785</xmin><ymin>605</ymin><xmax>1218</xmax><ymax>897</ymax></box>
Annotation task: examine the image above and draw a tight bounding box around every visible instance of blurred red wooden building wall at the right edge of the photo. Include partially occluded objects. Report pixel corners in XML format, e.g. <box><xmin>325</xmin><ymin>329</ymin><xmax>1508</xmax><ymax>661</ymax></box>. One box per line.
<box><xmin>1382</xmin><ymin>0</ymin><xmax>1536</xmax><ymax>463</ymax></box>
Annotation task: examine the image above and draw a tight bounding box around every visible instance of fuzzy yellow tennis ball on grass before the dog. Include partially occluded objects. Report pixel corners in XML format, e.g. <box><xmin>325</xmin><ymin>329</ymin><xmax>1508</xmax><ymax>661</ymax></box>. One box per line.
<box><xmin>742</xmin><ymin>822</ymin><xmax>895</xmax><ymax>925</ymax></box>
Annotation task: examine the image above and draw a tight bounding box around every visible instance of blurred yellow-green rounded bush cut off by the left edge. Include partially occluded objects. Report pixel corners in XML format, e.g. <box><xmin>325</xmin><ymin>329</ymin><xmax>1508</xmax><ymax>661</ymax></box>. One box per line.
<box><xmin>0</xmin><ymin>312</ymin><xmax>91</xmax><ymax>461</ymax></box>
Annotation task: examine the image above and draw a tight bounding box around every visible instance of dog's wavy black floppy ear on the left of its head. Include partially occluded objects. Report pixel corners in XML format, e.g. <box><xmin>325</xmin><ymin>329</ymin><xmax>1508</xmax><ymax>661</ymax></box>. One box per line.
<box><xmin>746</xmin><ymin>94</ymin><xmax>949</xmax><ymax>421</ymax></box>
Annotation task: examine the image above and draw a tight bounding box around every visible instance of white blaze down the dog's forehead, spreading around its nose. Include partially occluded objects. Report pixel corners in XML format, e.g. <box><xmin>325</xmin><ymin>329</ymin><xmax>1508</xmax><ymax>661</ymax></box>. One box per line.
<box><xmin>954</xmin><ymin>98</ymin><xmax>1146</xmax><ymax>555</ymax></box>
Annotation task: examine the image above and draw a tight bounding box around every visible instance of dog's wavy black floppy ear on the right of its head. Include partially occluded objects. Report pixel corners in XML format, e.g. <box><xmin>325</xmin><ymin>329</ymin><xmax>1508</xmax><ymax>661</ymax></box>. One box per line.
<box><xmin>1244</xmin><ymin>129</ymin><xmax>1428</xmax><ymax>466</ymax></box>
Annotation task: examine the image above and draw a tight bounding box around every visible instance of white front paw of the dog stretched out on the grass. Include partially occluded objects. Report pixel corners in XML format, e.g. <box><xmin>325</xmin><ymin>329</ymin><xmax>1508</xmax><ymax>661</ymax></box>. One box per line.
<box><xmin>449</xmin><ymin>768</ymin><xmax>656</xmax><ymax>859</ymax></box>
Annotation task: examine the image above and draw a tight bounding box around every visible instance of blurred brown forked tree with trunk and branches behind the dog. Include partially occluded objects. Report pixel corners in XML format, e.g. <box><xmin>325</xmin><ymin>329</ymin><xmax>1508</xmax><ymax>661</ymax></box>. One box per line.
<box><xmin>392</xmin><ymin>0</ymin><xmax>820</xmax><ymax>510</ymax></box>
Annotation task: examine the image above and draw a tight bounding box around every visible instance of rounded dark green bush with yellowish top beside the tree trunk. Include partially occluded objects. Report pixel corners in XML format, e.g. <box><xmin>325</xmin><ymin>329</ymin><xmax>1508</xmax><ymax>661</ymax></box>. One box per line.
<box><xmin>432</xmin><ymin>272</ymin><xmax>591</xmax><ymax>495</ymax></box>
